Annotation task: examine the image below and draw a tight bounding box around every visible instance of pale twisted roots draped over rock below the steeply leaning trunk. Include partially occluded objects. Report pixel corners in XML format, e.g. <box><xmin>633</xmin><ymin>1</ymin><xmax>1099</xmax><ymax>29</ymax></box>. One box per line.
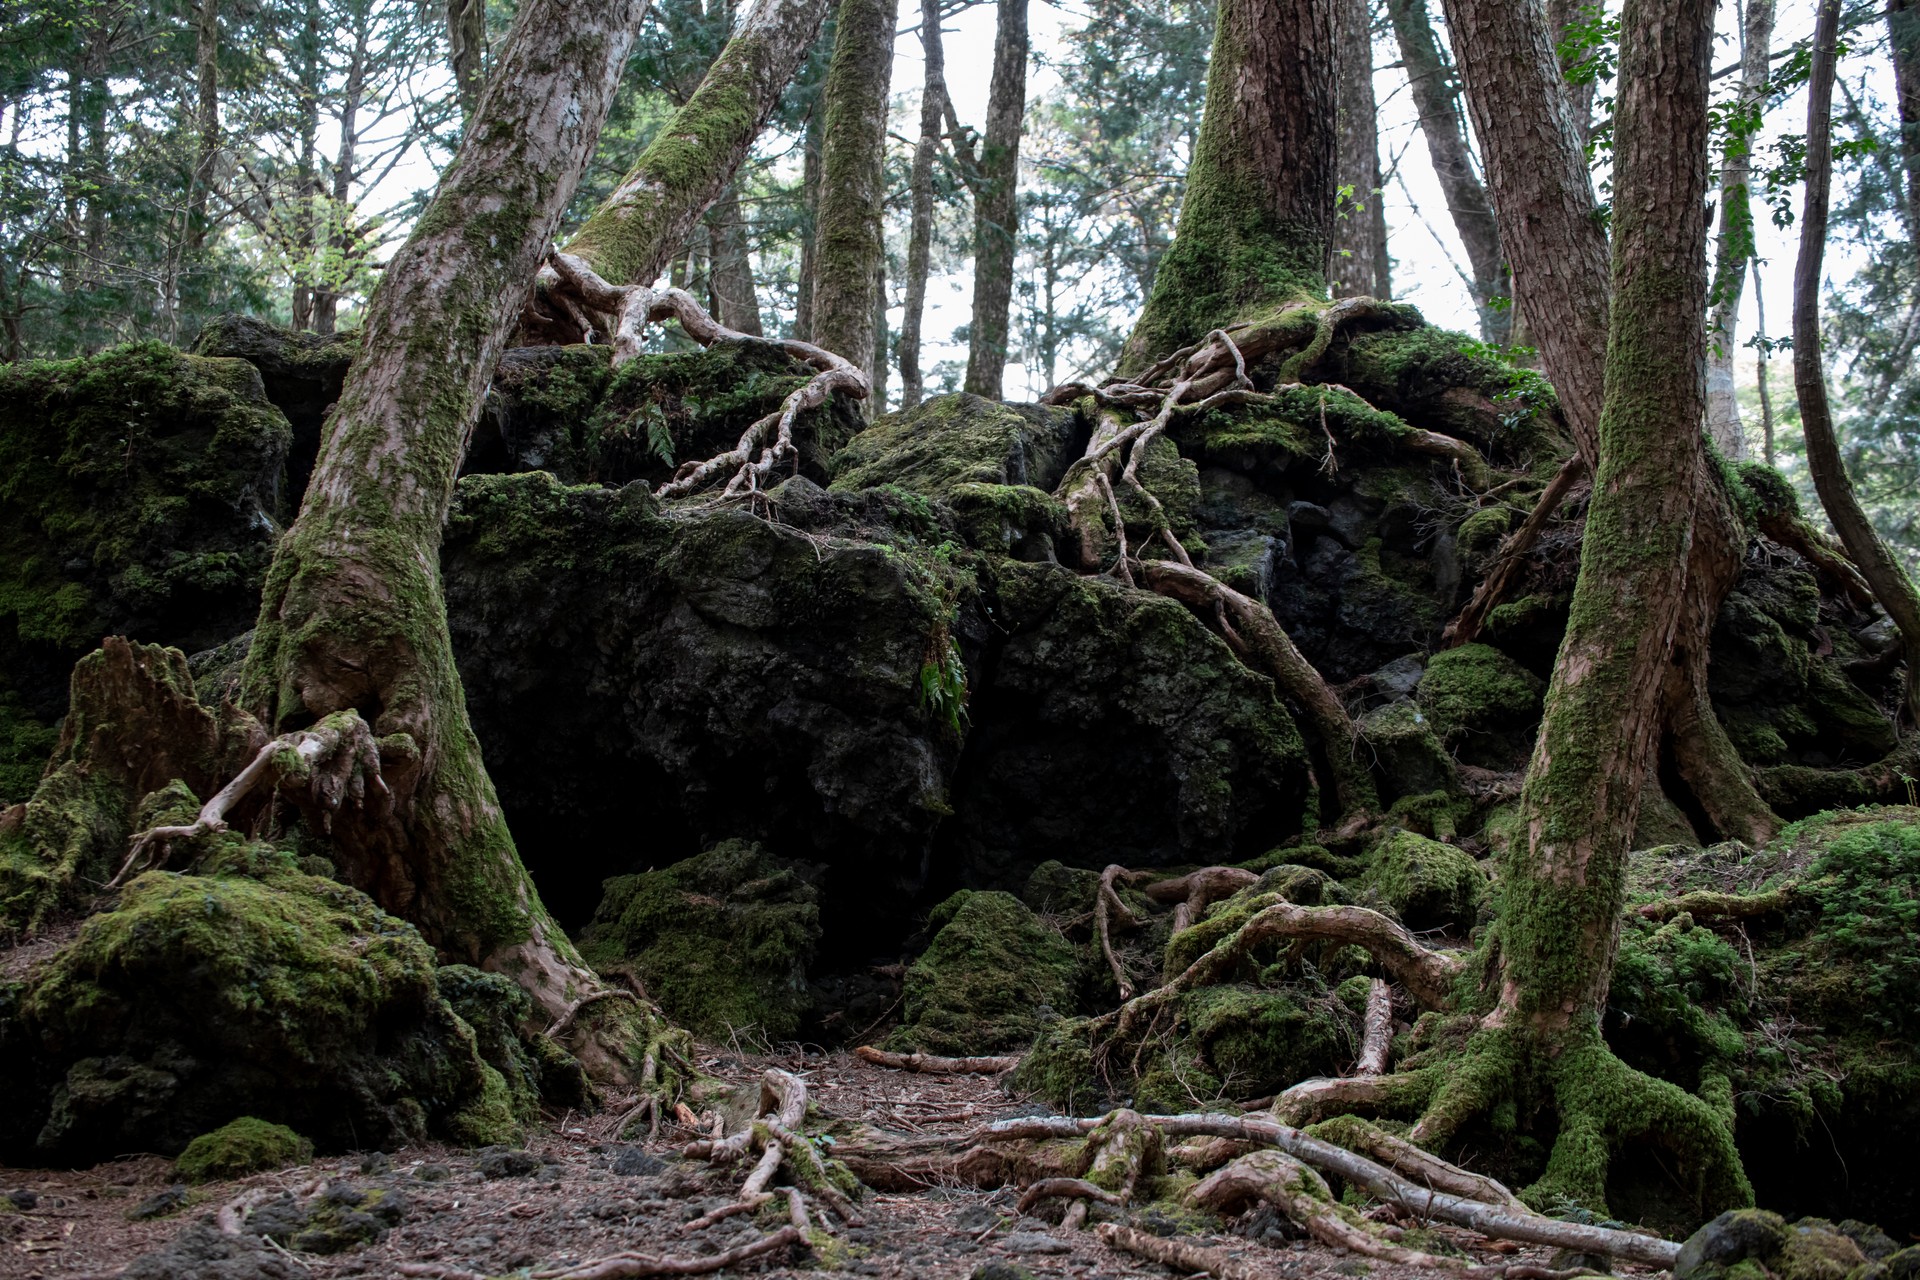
<box><xmin>547</xmin><ymin>249</ymin><xmax>872</xmax><ymax>497</ymax></box>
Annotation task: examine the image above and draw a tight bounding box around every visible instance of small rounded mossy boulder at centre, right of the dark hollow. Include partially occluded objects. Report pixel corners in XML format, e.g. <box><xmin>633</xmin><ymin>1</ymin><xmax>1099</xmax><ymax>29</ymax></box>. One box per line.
<box><xmin>889</xmin><ymin>890</ymin><xmax>1075</xmax><ymax>1055</ymax></box>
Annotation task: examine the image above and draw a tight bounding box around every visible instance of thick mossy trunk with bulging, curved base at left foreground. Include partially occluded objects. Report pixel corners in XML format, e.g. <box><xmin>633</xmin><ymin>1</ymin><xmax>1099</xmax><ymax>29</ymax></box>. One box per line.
<box><xmin>242</xmin><ymin>0</ymin><xmax>645</xmax><ymax>1043</ymax></box>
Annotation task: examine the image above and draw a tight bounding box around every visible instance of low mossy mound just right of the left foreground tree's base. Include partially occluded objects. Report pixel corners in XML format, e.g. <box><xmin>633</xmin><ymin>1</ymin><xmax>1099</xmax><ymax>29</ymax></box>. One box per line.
<box><xmin>580</xmin><ymin>841</ymin><xmax>820</xmax><ymax>1040</ymax></box>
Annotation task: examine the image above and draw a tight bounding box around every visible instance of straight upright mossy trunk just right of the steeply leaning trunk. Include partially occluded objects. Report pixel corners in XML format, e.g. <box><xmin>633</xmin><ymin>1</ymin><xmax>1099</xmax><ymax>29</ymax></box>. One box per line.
<box><xmin>812</xmin><ymin>0</ymin><xmax>899</xmax><ymax>378</ymax></box>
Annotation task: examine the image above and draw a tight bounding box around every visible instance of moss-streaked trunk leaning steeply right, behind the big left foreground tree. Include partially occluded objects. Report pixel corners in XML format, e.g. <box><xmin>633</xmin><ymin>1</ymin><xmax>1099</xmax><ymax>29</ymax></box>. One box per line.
<box><xmin>566</xmin><ymin>0</ymin><xmax>828</xmax><ymax>284</ymax></box>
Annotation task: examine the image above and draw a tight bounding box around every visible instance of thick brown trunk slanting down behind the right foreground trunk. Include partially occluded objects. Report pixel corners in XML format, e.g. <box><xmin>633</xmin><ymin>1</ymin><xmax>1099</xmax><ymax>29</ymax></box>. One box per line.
<box><xmin>1446</xmin><ymin>0</ymin><xmax>1607</xmax><ymax>445</ymax></box>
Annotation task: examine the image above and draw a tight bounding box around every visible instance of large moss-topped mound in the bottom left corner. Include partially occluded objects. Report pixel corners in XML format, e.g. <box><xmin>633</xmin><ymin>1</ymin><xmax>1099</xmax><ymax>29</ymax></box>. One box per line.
<box><xmin>0</xmin><ymin>859</ymin><xmax>516</xmax><ymax>1163</ymax></box>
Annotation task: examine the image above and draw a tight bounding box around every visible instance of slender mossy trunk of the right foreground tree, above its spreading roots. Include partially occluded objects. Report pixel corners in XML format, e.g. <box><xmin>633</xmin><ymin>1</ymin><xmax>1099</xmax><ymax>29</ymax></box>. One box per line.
<box><xmin>1497</xmin><ymin>0</ymin><xmax>1713</xmax><ymax>1036</ymax></box>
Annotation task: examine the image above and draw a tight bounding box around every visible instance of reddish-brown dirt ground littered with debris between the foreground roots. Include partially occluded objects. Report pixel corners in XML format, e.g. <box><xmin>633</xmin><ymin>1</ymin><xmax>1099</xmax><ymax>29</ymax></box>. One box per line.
<box><xmin>0</xmin><ymin>1052</ymin><xmax>1666</xmax><ymax>1280</ymax></box>
